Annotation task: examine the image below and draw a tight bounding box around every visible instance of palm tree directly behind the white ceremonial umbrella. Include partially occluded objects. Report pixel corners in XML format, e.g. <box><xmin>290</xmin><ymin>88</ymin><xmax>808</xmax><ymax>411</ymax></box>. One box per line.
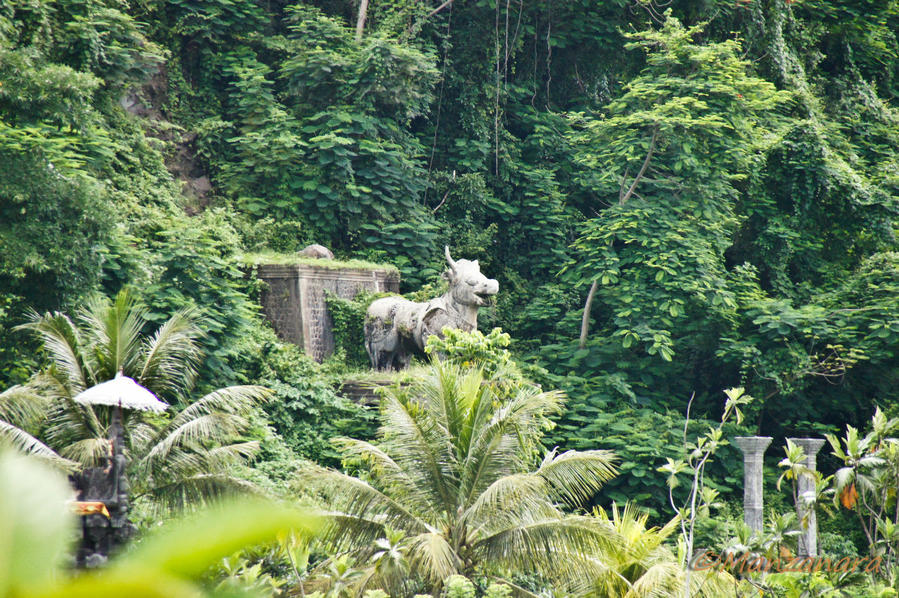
<box><xmin>0</xmin><ymin>291</ymin><xmax>269</xmax><ymax>506</ymax></box>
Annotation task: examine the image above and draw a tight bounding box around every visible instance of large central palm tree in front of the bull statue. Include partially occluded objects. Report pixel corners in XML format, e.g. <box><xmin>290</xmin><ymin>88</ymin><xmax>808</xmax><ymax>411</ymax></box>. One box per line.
<box><xmin>301</xmin><ymin>362</ymin><xmax>615</xmax><ymax>595</ymax></box>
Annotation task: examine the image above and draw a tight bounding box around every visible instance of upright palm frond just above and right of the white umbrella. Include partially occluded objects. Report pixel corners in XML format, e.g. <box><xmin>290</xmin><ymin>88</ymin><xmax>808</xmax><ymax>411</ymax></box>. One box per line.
<box><xmin>136</xmin><ymin>310</ymin><xmax>202</xmax><ymax>394</ymax></box>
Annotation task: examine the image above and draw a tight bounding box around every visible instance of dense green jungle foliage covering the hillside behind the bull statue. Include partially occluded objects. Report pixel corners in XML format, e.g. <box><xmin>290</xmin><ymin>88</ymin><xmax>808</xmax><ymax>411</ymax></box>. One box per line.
<box><xmin>0</xmin><ymin>0</ymin><xmax>899</xmax><ymax>593</ymax></box>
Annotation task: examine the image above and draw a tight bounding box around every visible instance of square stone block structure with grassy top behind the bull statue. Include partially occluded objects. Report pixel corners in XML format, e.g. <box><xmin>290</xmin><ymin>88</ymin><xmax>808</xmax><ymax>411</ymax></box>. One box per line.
<box><xmin>257</xmin><ymin>245</ymin><xmax>400</xmax><ymax>362</ymax></box>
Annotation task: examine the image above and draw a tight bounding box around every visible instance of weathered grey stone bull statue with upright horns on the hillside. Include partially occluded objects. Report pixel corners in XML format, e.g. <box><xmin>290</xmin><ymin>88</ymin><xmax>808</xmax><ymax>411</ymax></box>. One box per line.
<box><xmin>365</xmin><ymin>247</ymin><xmax>499</xmax><ymax>370</ymax></box>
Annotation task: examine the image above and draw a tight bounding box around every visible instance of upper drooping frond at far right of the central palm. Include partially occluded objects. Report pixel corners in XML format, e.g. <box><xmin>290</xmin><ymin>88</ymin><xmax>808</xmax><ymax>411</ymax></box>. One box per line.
<box><xmin>535</xmin><ymin>450</ymin><xmax>618</xmax><ymax>507</ymax></box>
